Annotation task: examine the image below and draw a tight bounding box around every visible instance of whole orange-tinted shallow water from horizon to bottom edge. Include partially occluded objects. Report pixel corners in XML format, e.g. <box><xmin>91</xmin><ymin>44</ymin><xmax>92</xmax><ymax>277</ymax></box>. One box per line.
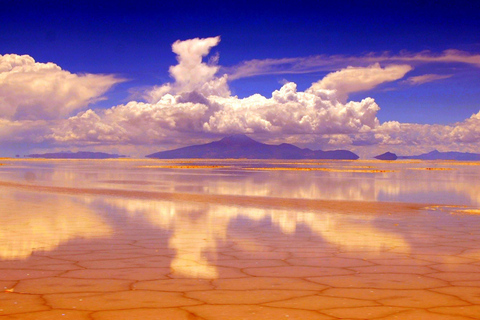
<box><xmin>0</xmin><ymin>160</ymin><xmax>480</xmax><ymax>319</ymax></box>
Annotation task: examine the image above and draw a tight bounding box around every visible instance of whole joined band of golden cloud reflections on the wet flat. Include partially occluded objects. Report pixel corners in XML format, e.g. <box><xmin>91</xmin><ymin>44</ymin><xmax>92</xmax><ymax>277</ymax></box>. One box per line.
<box><xmin>0</xmin><ymin>191</ymin><xmax>410</xmax><ymax>279</ymax></box>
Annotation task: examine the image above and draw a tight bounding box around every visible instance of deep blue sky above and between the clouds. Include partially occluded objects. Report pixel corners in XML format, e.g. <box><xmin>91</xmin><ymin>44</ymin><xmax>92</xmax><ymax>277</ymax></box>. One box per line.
<box><xmin>0</xmin><ymin>0</ymin><xmax>480</xmax><ymax>124</ymax></box>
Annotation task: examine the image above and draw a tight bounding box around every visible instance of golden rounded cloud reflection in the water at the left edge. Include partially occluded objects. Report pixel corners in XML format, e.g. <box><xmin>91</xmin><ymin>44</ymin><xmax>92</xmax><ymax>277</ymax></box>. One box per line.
<box><xmin>0</xmin><ymin>190</ymin><xmax>112</xmax><ymax>259</ymax></box>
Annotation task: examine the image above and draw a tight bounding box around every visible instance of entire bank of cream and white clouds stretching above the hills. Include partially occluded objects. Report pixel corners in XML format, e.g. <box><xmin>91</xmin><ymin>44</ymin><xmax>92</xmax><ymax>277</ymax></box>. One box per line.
<box><xmin>0</xmin><ymin>37</ymin><xmax>480</xmax><ymax>155</ymax></box>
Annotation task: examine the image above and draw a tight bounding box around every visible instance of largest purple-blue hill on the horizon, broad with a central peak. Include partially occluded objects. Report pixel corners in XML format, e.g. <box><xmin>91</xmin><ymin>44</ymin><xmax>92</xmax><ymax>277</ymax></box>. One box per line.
<box><xmin>146</xmin><ymin>134</ymin><xmax>358</xmax><ymax>160</ymax></box>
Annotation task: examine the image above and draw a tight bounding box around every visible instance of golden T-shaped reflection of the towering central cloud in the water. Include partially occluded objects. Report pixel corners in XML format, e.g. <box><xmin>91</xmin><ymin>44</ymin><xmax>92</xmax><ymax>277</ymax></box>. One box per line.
<box><xmin>104</xmin><ymin>198</ymin><xmax>409</xmax><ymax>279</ymax></box>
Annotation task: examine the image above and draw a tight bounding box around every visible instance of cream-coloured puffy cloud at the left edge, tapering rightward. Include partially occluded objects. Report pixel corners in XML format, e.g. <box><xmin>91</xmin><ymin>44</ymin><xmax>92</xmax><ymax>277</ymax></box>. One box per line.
<box><xmin>0</xmin><ymin>54</ymin><xmax>123</xmax><ymax>120</ymax></box>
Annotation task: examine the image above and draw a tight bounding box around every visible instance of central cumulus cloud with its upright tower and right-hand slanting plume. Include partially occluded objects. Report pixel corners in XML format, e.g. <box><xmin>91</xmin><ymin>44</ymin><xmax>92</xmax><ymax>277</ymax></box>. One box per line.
<box><xmin>50</xmin><ymin>37</ymin><xmax>390</xmax><ymax>144</ymax></box>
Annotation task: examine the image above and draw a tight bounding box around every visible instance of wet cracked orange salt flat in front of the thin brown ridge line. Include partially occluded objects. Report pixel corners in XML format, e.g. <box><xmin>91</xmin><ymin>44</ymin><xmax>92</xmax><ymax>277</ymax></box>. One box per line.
<box><xmin>0</xmin><ymin>161</ymin><xmax>480</xmax><ymax>319</ymax></box>
